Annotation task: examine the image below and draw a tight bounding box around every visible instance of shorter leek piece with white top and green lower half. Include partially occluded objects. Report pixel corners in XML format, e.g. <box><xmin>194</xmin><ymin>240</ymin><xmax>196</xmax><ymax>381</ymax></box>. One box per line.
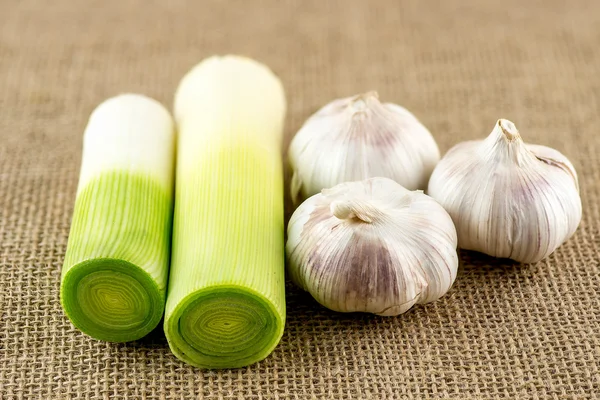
<box><xmin>60</xmin><ymin>94</ymin><xmax>175</xmax><ymax>342</ymax></box>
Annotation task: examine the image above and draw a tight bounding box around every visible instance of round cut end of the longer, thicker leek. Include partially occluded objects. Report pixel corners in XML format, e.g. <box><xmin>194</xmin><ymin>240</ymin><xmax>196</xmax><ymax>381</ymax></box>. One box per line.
<box><xmin>165</xmin><ymin>287</ymin><xmax>285</xmax><ymax>368</ymax></box>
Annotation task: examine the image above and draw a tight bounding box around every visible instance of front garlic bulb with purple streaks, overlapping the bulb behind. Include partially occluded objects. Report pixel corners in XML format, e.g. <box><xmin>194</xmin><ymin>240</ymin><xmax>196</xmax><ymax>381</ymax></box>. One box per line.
<box><xmin>286</xmin><ymin>178</ymin><xmax>458</xmax><ymax>315</ymax></box>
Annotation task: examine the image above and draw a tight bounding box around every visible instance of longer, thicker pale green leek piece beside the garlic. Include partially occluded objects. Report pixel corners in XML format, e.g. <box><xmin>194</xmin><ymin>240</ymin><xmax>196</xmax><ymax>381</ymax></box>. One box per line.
<box><xmin>164</xmin><ymin>56</ymin><xmax>286</xmax><ymax>368</ymax></box>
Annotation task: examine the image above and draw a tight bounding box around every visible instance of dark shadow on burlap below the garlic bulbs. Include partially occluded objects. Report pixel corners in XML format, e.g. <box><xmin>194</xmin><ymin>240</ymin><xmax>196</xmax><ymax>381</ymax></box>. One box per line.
<box><xmin>284</xmin><ymin>250</ymin><xmax>543</xmax><ymax>345</ymax></box>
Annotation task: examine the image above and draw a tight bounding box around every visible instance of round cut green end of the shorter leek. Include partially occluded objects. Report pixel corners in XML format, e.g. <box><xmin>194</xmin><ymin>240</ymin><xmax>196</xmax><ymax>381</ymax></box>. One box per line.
<box><xmin>61</xmin><ymin>258</ymin><xmax>164</xmax><ymax>342</ymax></box>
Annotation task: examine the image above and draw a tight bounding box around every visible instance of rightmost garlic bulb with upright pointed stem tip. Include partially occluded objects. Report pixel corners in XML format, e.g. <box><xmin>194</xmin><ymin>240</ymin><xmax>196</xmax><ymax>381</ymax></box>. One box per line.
<box><xmin>428</xmin><ymin>119</ymin><xmax>581</xmax><ymax>263</ymax></box>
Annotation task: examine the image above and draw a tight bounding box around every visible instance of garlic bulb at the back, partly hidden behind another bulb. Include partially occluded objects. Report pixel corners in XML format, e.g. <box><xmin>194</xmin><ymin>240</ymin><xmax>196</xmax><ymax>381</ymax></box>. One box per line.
<box><xmin>288</xmin><ymin>92</ymin><xmax>440</xmax><ymax>203</ymax></box>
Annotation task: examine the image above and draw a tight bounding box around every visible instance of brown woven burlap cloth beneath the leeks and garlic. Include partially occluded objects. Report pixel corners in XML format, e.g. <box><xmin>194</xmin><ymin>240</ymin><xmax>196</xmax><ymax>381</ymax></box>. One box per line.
<box><xmin>0</xmin><ymin>0</ymin><xmax>600</xmax><ymax>400</ymax></box>
